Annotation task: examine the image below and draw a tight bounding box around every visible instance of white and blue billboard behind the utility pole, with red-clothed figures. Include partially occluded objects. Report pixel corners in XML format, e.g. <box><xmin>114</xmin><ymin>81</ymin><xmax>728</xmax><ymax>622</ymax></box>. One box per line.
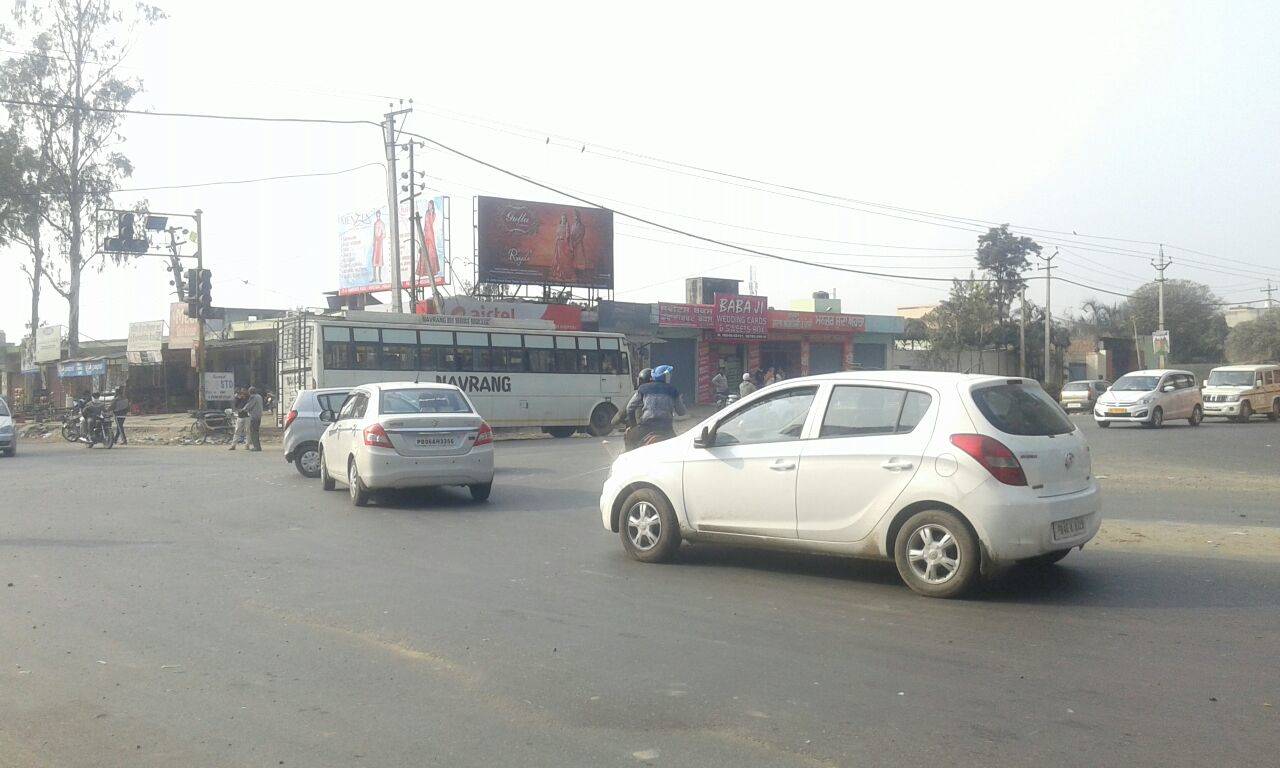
<box><xmin>338</xmin><ymin>197</ymin><xmax>449</xmax><ymax>296</ymax></box>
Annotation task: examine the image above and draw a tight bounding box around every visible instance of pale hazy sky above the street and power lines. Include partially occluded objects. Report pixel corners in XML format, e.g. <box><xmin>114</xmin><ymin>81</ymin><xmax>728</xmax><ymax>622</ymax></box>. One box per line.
<box><xmin>0</xmin><ymin>0</ymin><xmax>1280</xmax><ymax>340</ymax></box>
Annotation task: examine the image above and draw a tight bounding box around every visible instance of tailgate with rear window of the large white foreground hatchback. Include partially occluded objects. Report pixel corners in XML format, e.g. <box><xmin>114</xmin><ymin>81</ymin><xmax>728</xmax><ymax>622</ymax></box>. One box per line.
<box><xmin>963</xmin><ymin>379</ymin><xmax>1093</xmax><ymax>498</ymax></box>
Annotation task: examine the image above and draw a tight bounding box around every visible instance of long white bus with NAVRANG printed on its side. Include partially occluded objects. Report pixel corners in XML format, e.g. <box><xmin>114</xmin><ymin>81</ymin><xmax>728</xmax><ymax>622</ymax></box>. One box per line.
<box><xmin>278</xmin><ymin>311</ymin><xmax>635</xmax><ymax>438</ymax></box>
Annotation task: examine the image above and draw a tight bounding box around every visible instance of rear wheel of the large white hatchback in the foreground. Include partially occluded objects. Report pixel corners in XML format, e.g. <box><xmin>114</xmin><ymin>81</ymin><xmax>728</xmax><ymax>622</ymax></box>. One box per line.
<box><xmin>893</xmin><ymin>509</ymin><xmax>980</xmax><ymax>598</ymax></box>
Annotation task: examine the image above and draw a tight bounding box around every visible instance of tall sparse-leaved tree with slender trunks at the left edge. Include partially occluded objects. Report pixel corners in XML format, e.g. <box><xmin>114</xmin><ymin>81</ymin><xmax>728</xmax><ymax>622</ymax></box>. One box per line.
<box><xmin>0</xmin><ymin>0</ymin><xmax>164</xmax><ymax>356</ymax></box>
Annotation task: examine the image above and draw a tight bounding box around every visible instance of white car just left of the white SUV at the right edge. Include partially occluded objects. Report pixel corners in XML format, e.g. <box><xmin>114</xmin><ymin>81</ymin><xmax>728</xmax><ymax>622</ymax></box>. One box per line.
<box><xmin>1093</xmin><ymin>370</ymin><xmax>1204</xmax><ymax>429</ymax></box>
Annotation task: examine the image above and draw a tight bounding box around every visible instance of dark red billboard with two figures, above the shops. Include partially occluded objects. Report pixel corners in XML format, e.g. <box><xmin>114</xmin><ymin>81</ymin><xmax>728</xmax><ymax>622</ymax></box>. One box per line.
<box><xmin>476</xmin><ymin>197</ymin><xmax>613</xmax><ymax>289</ymax></box>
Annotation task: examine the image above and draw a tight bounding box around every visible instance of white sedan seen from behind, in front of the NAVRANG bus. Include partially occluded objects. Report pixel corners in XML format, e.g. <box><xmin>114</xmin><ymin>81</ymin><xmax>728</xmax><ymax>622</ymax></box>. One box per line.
<box><xmin>320</xmin><ymin>381</ymin><xmax>493</xmax><ymax>507</ymax></box>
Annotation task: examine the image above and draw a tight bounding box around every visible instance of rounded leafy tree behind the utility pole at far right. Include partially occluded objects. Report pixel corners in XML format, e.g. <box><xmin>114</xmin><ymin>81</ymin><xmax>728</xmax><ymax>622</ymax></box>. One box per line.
<box><xmin>1124</xmin><ymin>280</ymin><xmax>1228</xmax><ymax>364</ymax></box>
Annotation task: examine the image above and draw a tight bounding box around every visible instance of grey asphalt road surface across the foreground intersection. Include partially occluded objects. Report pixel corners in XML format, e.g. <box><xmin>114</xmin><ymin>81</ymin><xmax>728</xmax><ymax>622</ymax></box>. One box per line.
<box><xmin>0</xmin><ymin>422</ymin><xmax>1280</xmax><ymax>768</ymax></box>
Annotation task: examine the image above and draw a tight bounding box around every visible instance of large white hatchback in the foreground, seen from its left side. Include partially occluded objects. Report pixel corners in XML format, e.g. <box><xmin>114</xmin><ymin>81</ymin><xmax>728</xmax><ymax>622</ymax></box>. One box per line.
<box><xmin>600</xmin><ymin>371</ymin><xmax>1101</xmax><ymax>596</ymax></box>
